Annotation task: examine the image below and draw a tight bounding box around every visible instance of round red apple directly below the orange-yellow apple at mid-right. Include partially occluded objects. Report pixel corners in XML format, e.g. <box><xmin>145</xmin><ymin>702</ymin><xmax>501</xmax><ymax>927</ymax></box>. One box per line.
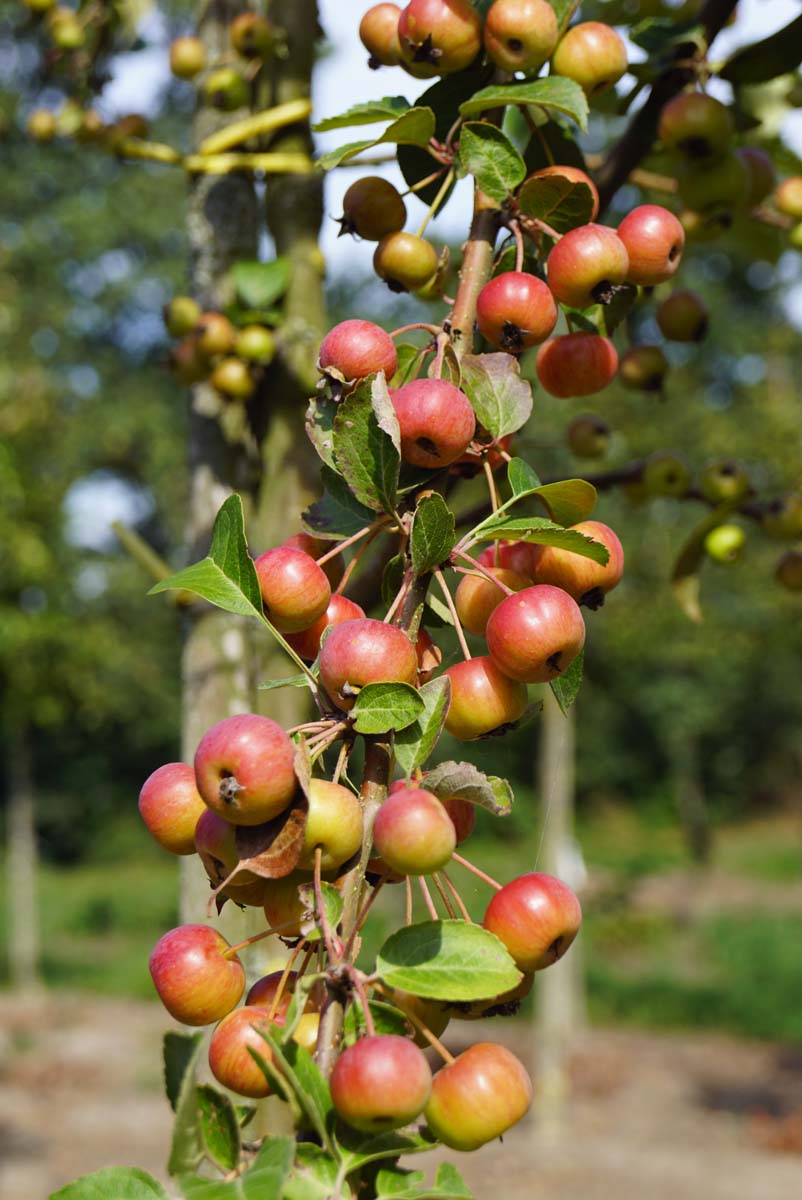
<box><xmin>486</xmin><ymin>583</ymin><xmax>585</xmax><ymax>683</ymax></box>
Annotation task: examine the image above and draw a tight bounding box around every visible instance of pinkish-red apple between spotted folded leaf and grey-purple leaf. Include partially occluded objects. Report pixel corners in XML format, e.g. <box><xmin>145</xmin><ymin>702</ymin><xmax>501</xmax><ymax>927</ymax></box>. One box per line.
<box><xmin>390</xmin><ymin>379</ymin><xmax>477</xmax><ymax>470</ymax></box>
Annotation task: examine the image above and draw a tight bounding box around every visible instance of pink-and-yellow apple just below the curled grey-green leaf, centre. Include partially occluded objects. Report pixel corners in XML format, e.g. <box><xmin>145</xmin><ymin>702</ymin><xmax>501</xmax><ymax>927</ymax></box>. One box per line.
<box><xmin>373</xmin><ymin>787</ymin><xmax>456</xmax><ymax>875</ymax></box>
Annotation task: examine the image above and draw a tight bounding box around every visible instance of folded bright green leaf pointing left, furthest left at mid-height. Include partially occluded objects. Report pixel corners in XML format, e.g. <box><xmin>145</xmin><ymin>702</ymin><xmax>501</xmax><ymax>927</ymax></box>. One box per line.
<box><xmin>148</xmin><ymin>493</ymin><xmax>264</xmax><ymax>620</ymax></box>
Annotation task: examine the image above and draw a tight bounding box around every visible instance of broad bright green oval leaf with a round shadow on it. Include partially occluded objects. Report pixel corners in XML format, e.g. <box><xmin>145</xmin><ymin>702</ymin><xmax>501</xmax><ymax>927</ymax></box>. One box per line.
<box><xmin>376</xmin><ymin>920</ymin><xmax>522</xmax><ymax>1001</ymax></box>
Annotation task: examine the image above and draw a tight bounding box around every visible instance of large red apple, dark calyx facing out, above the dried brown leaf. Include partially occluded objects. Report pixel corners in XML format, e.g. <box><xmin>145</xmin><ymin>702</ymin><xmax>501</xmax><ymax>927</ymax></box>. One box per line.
<box><xmin>194</xmin><ymin>713</ymin><xmax>297</xmax><ymax>826</ymax></box>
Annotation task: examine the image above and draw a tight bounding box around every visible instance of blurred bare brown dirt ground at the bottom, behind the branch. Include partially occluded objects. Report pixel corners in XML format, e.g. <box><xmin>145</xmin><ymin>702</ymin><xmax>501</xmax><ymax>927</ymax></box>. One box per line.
<box><xmin>0</xmin><ymin>996</ymin><xmax>802</xmax><ymax>1200</ymax></box>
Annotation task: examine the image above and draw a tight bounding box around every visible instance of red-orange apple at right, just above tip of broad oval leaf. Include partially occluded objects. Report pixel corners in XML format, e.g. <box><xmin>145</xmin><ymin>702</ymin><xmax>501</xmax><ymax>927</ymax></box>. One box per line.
<box><xmin>483</xmin><ymin>871</ymin><xmax>582</xmax><ymax>973</ymax></box>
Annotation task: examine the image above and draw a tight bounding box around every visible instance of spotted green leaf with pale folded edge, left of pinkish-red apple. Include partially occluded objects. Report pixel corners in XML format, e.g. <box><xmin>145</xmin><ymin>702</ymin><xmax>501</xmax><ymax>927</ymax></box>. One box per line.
<box><xmin>334</xmin><ymin>376</ymin><xmax>401</xmax><ymax>512</ymax></box>
